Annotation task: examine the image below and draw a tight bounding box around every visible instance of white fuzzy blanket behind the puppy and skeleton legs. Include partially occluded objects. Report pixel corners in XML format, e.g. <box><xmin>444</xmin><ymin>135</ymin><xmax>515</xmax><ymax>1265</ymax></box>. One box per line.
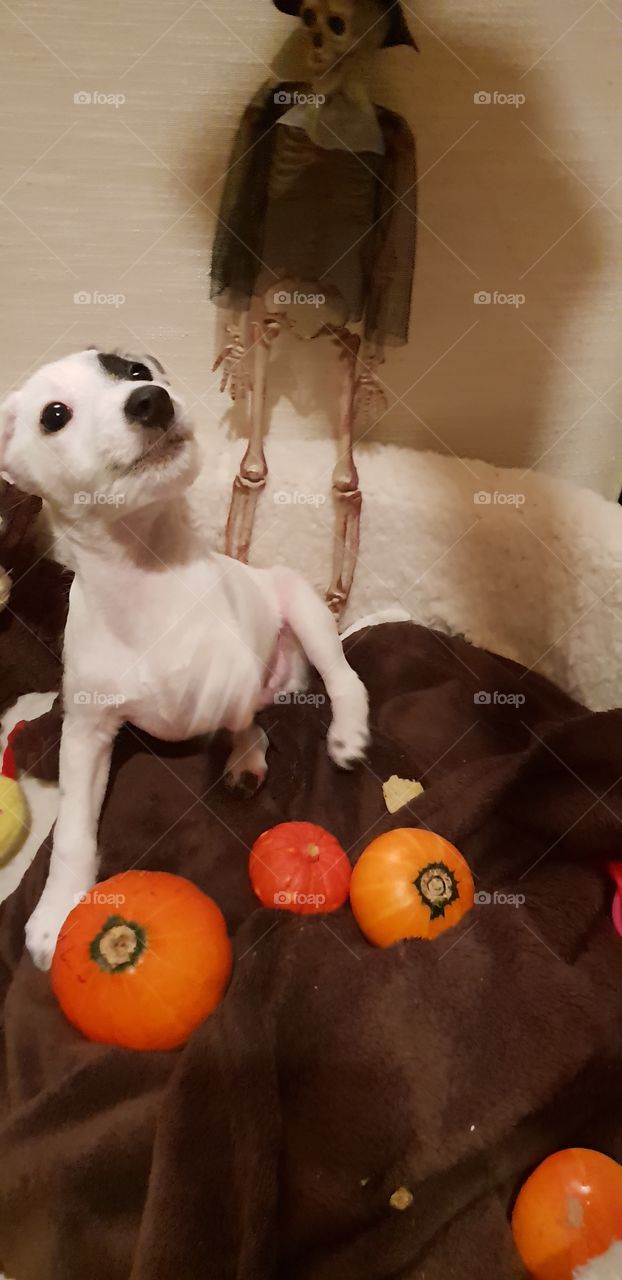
<box><xmin>195</xmin><ymin>438</ymin><xmax>622</xmax><ymax>710</ymax></box>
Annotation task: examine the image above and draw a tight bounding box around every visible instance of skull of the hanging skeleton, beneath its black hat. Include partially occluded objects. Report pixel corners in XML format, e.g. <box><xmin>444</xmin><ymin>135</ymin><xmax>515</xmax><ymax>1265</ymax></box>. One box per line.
<box><xmin>301</xmin><ymin>0</ymin><xmax>389</xmax><ymax>76</ymax></box>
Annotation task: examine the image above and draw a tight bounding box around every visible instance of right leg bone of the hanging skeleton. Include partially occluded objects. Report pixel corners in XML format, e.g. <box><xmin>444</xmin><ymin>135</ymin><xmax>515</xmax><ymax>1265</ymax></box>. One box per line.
<box><xmin>326</xmin><ymin>329</ymin><xmax>362</xmax><ymax>617</ymax></box>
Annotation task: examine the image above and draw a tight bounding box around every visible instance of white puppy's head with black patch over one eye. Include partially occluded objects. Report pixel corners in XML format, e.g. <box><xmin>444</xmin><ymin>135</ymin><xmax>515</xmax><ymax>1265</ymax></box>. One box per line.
<box><xmin>0</xmin><ymin>349</ymin><xmax>198</xmax><ymax>517</ymax></box>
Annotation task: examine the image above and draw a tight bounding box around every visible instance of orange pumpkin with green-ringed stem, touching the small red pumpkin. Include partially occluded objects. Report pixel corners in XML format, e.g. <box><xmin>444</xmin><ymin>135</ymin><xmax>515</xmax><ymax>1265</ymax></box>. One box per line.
<box><xmin>349</xmin><ymin>827</ymin><xmax>475</xmax><ymax>947</ymax></box>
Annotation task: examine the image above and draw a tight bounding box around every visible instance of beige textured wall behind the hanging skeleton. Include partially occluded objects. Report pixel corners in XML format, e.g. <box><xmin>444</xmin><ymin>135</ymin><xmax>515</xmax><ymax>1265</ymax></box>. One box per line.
<box><xmin>0</xmin><ymin>0</ymin><xmax>622</xmax><ymax>497</ymax></box>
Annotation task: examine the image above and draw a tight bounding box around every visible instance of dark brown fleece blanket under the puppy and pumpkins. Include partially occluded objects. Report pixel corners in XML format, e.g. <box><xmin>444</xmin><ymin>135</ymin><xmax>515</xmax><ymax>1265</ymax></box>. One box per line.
<box><xmin>0</xmin><ymin>601</ymin><xmax>622</xmax><ymax>1280</ymax></box>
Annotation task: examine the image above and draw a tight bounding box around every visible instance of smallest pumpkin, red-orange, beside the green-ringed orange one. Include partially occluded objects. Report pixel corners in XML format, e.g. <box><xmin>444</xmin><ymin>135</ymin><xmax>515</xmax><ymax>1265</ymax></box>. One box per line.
<box><xmin>248</xmin><ymin>822</ymin><xmax>352</xmax><ymax>915</ymax></box>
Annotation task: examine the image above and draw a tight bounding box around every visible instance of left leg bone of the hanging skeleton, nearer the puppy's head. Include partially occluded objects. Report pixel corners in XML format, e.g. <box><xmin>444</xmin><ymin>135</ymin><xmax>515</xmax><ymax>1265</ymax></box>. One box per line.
<box><xmin>225</xmin><ymin>315</ymin><xmax>280</xmax><ymax>564</ymax></box>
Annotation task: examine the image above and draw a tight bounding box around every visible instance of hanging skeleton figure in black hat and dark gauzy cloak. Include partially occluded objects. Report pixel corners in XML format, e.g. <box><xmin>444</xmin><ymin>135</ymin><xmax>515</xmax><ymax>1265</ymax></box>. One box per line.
<box><xmin>211</xmin><ymin>0</ymin><xmax>416</xmax><ymax>614</ymax></box>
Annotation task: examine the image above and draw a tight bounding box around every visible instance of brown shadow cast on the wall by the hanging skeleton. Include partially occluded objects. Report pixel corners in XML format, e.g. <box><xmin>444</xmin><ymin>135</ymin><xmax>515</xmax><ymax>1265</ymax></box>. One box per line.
<box><xmin>197</xmin><ymin>13</ymin><xmax>608</xmax><ymax>466</ymax></box>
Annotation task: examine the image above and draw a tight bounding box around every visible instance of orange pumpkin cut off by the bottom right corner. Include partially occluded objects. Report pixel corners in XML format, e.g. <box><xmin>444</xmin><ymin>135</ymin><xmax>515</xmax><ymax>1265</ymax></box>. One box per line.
<box><xmin>512</xmin><ymin>1147</ymin><xmax>622</xmax><ymax>1280</ymax></box>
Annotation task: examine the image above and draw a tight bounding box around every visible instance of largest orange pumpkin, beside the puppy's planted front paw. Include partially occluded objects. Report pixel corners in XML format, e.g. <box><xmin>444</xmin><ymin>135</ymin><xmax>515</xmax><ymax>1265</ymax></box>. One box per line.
<box><xmin>51</xmin><ymin>872</ymin><xmax>232</xmax><ymax>1050</ymax></box>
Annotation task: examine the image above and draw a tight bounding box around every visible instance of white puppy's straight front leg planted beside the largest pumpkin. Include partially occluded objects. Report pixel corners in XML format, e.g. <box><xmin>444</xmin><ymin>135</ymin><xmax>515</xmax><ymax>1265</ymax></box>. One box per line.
<box><xmin>26</xmin><ymin>707</ymin><xmax>118</xmax><ymax>969</ymax></box>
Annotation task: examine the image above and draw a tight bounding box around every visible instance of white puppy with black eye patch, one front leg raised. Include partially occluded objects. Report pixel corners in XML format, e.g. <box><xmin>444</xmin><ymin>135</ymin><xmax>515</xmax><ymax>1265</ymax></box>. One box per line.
<box><xmin>0</xmin><ymin>349</ymin><xmax>369</xmax><ymax>968</ymax></box>
